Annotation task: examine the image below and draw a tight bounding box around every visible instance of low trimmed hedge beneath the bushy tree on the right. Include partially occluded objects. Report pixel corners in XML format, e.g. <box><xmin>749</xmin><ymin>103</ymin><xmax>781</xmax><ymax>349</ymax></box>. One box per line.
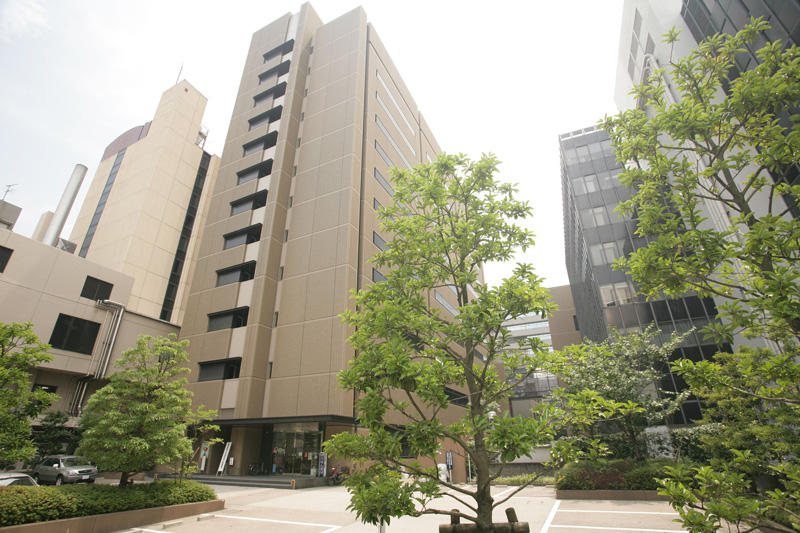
<box><xmin>556</xmin><ymin>459</ymin><xmax>675</xmax><ymax>490</ymax></box>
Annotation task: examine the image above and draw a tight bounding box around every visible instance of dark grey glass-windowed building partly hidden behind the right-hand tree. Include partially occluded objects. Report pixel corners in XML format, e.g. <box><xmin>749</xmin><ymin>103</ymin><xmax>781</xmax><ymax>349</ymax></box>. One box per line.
<box><xmin>559</xmin><ymin>128</ymin><xmax>730</xmax><ymax>424</ymax></box>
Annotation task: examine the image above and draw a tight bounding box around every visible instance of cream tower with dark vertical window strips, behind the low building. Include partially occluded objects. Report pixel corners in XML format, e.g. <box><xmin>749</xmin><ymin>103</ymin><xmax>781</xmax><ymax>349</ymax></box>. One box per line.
<box><xmin>69</xmin><ymin>80</ymin><xmax>219</xmax><ymax>324</ymax></box>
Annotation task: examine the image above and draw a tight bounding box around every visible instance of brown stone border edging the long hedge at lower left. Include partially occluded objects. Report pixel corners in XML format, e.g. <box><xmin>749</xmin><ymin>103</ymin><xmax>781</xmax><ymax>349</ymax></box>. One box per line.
<box><xmin>0</xmin><ymin>500</ymin><xmax>225</xmax><ymax>533</ymax></box>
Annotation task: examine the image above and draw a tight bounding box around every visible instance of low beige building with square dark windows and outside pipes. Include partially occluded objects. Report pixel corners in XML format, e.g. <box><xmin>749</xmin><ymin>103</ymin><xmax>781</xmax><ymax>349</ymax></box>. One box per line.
<box><xmin>0</xmin><ymin>229</ymin><xmax>178</xmax><ymax>416</ymax></box>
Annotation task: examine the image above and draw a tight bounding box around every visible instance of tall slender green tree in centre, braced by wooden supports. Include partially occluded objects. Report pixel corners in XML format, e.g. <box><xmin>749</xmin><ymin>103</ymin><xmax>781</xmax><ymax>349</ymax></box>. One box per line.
<box><xmin>325</xmin><ymin>155</ymin><xmax>553</xmax><ymax>531</ymax></box>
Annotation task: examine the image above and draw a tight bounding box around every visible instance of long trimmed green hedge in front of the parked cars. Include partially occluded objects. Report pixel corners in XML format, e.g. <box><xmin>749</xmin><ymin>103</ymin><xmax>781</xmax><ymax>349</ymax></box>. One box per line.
<box><xmin>0</xmin><ymin>481</ymin><xmax>217</xmax><ymax>527</ymax></box>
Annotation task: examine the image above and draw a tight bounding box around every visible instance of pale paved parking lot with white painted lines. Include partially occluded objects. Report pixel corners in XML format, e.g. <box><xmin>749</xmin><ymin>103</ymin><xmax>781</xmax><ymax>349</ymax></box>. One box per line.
<box><xmin>122</xmin><ymin>486</ymin><xmax>683</xmax><ymax>533</ymax></box>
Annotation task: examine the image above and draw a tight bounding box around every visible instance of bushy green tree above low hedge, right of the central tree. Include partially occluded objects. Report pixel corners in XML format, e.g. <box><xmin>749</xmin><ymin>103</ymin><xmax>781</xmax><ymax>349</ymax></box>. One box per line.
<box><xmin>547</xmin><ymin>326</ymin><xmax>688</xmax><ymax>460</ymax></box>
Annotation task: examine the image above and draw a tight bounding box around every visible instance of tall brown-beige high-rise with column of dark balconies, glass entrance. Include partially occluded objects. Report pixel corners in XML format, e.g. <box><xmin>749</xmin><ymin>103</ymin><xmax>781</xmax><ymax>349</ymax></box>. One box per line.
<box><xmin>181</xmin><ymin>4</ymin><xmax>464</xmax><ymax>479</ymax></box>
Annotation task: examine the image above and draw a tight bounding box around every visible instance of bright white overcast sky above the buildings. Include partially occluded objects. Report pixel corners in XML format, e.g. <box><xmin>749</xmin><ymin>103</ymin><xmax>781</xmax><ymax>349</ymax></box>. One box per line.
<box><xmin>0</xmin><ymin>0</ymin><xmax>622</xmax><ymax>286</ymax></box>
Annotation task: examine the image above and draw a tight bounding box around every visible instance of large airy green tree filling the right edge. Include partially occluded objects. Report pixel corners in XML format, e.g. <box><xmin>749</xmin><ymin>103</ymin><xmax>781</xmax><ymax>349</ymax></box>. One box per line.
<box><xmin>604</xmin><ymin>20</ymin><xmax>800</xmax><ymax>531</ymax></box>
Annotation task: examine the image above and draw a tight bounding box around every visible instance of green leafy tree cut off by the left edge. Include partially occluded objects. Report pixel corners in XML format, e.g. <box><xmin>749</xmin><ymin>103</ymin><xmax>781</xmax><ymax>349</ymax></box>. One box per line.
<box><xmin>0</xmin><ymin>322</ymin><xmax>57</xmax><ymax>463</ymax></box>
